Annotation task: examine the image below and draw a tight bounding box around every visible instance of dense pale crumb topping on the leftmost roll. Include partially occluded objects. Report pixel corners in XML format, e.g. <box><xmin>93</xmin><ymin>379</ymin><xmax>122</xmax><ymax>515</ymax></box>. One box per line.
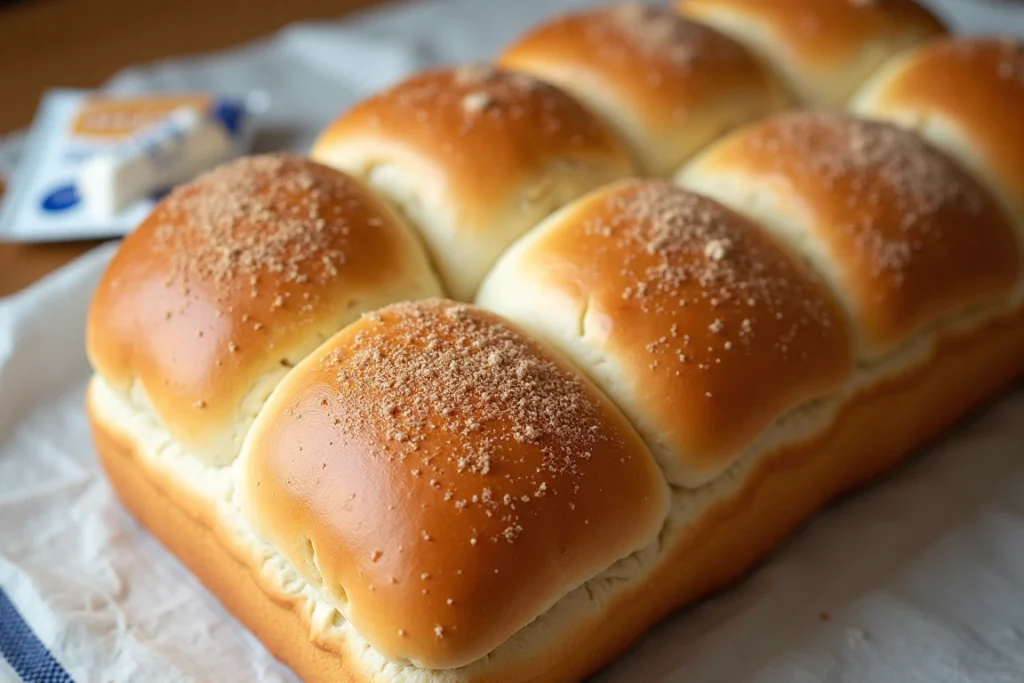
<box><xmin>153</xmin><ymin>154</ymin><xmax>360</xmax><ymax>294</ymax></box>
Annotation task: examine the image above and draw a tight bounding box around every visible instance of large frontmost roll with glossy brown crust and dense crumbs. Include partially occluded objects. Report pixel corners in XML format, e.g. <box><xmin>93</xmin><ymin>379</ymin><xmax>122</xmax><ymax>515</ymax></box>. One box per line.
<box><xmin>239</xmin><ymin>300</ymin><xmax>668</xmax><ymax>669</ymax></box>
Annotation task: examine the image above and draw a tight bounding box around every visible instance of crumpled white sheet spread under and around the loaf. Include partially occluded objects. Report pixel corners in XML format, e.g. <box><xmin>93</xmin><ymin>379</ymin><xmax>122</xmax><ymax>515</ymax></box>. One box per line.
<box><xmin>0</xmin><ymin>0</ymin><xmax>1024</xmax><ymax>683</ymax></box>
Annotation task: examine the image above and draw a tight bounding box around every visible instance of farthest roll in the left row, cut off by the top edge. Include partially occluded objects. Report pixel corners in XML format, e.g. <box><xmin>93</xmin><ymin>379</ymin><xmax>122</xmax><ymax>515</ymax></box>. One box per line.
<box><xmin>676</xmin><ymin>0</ymin><xmax>945</xmax><ymax>106</ymax></box>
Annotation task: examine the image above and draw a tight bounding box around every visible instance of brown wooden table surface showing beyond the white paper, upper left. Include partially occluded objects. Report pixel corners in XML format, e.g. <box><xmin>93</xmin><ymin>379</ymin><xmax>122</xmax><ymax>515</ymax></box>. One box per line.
<box><xmin>0</xmin><ymin>0</ymin><xmax>391</xmax><ymax>296</ymax></box>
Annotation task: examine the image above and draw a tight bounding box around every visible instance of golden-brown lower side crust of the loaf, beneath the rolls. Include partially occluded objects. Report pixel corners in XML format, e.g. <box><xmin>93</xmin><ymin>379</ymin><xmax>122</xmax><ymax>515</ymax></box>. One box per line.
<box><xmin>89</xmin><ymin>310</ymin><xmax>1024</xmax><ymax>683</ymax></box>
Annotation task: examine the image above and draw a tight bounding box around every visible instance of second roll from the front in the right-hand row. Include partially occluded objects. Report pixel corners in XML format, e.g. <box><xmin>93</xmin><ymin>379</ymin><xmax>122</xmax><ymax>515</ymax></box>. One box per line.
<box><xmin>478</xmin><ymin>180</ymin><xmax>852</xmax><ymax>486</ymax></box>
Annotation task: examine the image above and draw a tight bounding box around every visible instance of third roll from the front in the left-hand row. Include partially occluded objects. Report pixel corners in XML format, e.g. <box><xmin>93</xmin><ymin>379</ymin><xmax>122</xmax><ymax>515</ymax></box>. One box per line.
<box><xmin>499</xmin><ymin>3</ymin><xmax>786</xmax><ymax>176</ymax></box>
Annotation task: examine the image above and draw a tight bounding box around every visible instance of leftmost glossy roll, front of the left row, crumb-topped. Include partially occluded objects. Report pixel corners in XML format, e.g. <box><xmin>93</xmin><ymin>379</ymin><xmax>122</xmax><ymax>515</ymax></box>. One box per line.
<box><xmin>87</xmin><ymin>155</ymin><xmax>440</xmax><ymax>465</ymax></box>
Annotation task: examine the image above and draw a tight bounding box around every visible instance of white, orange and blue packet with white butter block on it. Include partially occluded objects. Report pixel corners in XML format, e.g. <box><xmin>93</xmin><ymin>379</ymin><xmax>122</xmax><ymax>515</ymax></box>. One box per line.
<box><xmin>0</xmin><ymin>89</ymin><xmax>262</xmax><ymax>242</ymax></box>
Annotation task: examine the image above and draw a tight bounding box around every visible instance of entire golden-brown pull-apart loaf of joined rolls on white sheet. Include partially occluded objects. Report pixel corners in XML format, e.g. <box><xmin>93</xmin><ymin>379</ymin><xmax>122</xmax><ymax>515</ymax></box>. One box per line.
<box><xmin>87</xmin><ymin>5</ymin><xmax>1024</xmax><ymax>683</ymax></box>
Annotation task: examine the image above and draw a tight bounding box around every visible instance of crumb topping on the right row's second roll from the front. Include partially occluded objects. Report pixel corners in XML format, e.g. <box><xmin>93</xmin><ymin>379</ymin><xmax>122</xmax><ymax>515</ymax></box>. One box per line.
<box><xmin>584</xmin><ymin>181</ymin><xmax>835</xmax><ymax>374</ymax></box>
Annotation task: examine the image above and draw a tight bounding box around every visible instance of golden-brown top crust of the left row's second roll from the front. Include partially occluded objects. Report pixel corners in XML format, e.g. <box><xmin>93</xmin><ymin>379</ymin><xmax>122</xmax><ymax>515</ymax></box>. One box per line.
<box><xmin>312</xmin><ymin>65</ymin><xmax>629</xmax><ymax>211</ymax></box>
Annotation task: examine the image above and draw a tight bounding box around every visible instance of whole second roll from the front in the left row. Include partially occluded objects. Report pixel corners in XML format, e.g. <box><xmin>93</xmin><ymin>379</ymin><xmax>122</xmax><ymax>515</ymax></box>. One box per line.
<box><xmin>312</xmin><ymin>65</ymin><xmax>634</xmax><ymax>300</ymax></box>
